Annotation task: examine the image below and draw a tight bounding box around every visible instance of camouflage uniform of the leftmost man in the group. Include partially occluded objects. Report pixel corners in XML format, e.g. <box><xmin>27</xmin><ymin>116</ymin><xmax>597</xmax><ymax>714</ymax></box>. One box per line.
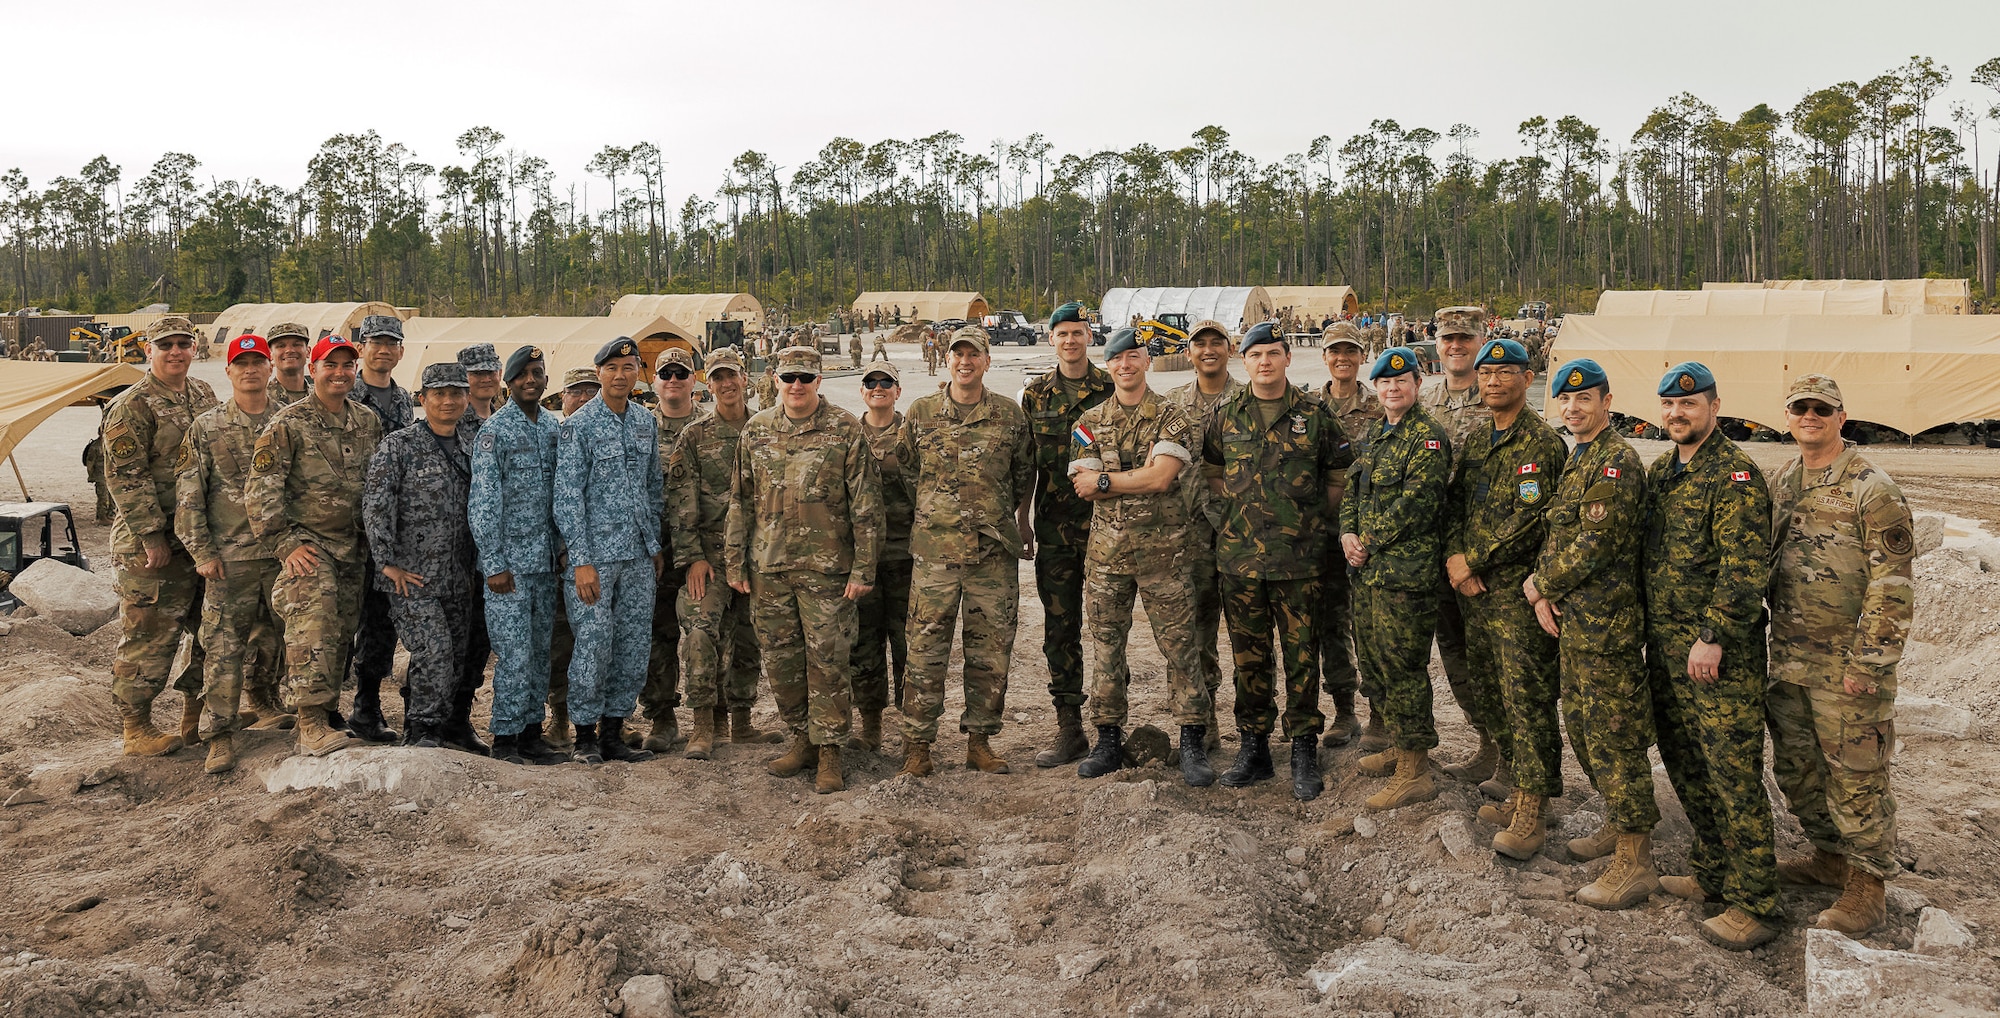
<box><xmin>98</xmin><ymin>372</ymin><xmax>216</xmax><ymax>708</ymax></box>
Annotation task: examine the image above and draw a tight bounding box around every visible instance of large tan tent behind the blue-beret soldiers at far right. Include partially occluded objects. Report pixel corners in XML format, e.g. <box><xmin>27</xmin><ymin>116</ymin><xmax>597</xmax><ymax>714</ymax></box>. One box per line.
<box><xmin>1544</xmin><ymin>314</ymin><xmax>2000</xmax><ymax>434</ymax></box>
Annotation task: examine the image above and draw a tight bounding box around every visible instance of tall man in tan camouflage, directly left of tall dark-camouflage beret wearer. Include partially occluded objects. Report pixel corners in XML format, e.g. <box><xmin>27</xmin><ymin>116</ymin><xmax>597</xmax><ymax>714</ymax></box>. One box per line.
<box><xmin>898</xmin><ymin>326</ymin><xmax>1040</xmax><ymax>778</ymax></box>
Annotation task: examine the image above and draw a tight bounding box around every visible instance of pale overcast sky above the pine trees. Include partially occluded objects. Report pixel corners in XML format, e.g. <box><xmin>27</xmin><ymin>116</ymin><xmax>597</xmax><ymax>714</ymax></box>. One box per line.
<box><xmin>11</xmin><ymin>0</ymin><xmax>2000</xmax><ymax>204</ymax></box>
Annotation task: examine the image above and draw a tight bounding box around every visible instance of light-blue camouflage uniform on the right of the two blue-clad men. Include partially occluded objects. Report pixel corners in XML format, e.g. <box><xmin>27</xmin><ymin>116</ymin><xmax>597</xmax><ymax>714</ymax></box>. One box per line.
<box><xmin>556</xmin><ymin>394</ymin><xmax>664</xmax><ymax>724</ymax></box>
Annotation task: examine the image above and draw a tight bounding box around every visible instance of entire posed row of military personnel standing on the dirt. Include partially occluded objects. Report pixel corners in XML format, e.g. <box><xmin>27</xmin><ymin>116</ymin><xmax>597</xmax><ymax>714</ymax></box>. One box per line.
<box><xmin>102</xmin><ymin>302</ymin><xmax>1914</xmax><ymax>948</ymax></box>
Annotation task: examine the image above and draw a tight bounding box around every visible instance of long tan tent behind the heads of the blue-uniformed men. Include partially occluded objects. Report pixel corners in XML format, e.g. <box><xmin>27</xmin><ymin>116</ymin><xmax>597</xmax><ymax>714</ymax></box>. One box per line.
<box><xmin>390</xmin><ymin>314</ymin><xmax>702</xmax><ymax>392</ymax></box>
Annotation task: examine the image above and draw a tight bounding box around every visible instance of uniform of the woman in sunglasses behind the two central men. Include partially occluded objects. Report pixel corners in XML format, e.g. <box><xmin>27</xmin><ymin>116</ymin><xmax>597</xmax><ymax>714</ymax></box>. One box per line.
<box><xmin>854</xmin><ymin>414</ymin><xmax>916</xmax><ymax>710</ymax></box>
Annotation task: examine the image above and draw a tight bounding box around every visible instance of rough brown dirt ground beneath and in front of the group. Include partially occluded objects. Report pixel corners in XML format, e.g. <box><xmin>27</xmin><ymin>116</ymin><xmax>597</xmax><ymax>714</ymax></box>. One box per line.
<box><xmin>0</xmin><ymin>350</ymin><xmax>2000</xmax><ymax>1018</ymax></box>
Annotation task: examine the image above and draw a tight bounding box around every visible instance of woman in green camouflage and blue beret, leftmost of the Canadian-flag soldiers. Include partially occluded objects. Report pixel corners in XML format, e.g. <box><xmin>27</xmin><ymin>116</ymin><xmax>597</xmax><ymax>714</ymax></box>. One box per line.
<box><xmin>1340</xmin><ymin>346</ymin><xmax>1452</xmax><ymax>810</ymax></box>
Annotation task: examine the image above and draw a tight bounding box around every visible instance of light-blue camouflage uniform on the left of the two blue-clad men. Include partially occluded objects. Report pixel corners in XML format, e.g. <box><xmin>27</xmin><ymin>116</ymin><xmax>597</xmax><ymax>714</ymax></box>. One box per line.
<box><xmin>468</xmin><ymin>400</ymin><xmax>560</xmax><ymax>736</ymax></box>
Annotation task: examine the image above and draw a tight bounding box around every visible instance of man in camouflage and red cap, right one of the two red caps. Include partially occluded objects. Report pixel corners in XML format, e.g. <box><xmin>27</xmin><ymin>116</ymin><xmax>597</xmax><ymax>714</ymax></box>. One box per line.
<box><xmin>244</xmin><ymin>334</ymin><xmax>382</xmax><ymax>756</ymax></box>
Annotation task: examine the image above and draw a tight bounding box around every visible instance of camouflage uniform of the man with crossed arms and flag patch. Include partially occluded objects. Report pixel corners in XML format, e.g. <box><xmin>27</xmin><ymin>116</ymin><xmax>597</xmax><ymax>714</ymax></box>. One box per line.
<box><xmin>1070</xmin><ymin>388</ymin><xmax>1210</xmax><ymax>728</ymax></box>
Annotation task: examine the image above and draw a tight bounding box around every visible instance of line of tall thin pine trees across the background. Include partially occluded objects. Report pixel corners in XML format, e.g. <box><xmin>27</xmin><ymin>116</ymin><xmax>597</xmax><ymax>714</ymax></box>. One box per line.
<box><xmin>0</xmin><ymin>56</ymin><xmax>2000</xmax><ymax>316</ymax></box>
